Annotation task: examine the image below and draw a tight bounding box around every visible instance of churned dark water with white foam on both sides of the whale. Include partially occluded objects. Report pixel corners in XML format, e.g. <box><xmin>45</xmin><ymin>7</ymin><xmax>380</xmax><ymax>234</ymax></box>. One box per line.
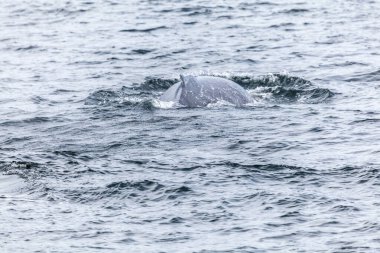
<box><xmin>85</xmin><ymin>72</ymin><xmax>334</xmax><ymax>109</ymax></box>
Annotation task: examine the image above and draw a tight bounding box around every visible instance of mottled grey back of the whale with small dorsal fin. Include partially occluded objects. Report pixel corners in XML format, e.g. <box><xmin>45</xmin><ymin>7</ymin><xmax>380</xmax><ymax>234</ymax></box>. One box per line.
<box><xmin>160</xmin><ymin>75</ymin><xmax>252</xmax><ymax>107</ymax></box>
